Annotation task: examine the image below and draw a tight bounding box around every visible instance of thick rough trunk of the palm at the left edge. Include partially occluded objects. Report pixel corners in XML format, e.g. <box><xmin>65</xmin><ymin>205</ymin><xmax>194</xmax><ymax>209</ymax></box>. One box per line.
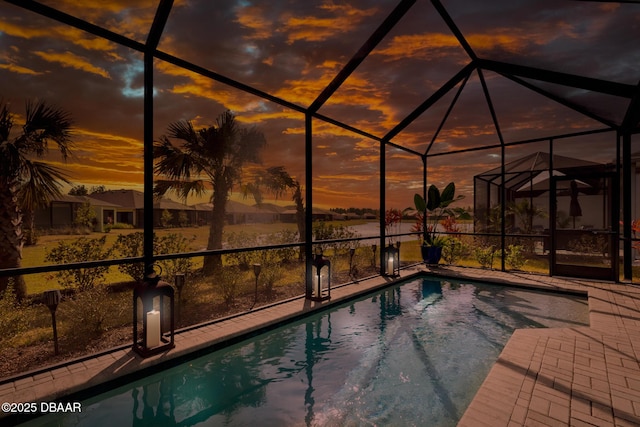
<box><xmin>0</xmin><ymin>181</ymin><xmax>26</xmax><ymax>299</ymax></box>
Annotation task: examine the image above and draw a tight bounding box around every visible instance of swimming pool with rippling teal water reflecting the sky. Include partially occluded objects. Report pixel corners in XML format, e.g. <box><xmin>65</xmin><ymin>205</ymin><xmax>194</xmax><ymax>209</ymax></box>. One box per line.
<box><xmin>22</xmin><ymin>278</ymin><xmax>588</xmax><ymax>427</ymax></box>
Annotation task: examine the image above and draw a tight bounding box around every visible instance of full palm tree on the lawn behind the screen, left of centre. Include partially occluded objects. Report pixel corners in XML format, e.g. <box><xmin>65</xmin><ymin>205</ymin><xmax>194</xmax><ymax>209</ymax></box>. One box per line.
<box><xmin>153</xmin><ymin>111</ymin><xmax>266</xmax><ymax>274</ymax></box>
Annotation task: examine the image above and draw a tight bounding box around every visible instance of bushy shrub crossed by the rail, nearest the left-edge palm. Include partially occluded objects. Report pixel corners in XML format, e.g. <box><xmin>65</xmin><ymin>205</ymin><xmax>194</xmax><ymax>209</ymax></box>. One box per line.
<box><xmin>44</xmin><ymin>236</ymin><xmax>112</xmax><ymax>291</ymax></box>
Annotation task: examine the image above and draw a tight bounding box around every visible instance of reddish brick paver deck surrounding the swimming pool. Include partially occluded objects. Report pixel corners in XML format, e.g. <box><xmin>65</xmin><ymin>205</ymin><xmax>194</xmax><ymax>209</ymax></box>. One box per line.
<box><xmin>0</xmin><ymin>265</ymin><xmax>640</xmax><ymax>427</ymax></box>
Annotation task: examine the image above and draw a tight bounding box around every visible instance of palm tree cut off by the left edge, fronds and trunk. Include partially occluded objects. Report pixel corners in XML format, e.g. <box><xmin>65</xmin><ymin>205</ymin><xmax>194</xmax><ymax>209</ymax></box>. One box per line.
<box><xmin>0</xmin><ymin>101</ymin><xmax>72</xmax><ymax>298</ymax></box>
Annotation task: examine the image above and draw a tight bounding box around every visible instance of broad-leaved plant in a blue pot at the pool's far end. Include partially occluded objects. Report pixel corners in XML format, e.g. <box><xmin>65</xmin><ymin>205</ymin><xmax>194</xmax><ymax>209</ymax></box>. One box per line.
<box><xmin>413</xmin><ymin>182</ymin><xmax>469</xmax><ymax>264</ymax></box>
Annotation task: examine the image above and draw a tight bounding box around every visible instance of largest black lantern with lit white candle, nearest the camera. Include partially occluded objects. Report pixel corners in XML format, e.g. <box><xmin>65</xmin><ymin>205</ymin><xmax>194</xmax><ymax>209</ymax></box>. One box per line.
<box><xmin>133</xmin><ymin>265</ymin><xmax>175</xmax><ymax>357</ymax></box>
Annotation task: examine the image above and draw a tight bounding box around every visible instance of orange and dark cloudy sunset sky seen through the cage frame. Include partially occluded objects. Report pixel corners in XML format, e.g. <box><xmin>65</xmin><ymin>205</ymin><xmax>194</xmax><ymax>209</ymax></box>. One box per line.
<box><xmin>0</xmin><ymin>0</ymin><xmax>640</xmax><ymax>208</ymax></box>
